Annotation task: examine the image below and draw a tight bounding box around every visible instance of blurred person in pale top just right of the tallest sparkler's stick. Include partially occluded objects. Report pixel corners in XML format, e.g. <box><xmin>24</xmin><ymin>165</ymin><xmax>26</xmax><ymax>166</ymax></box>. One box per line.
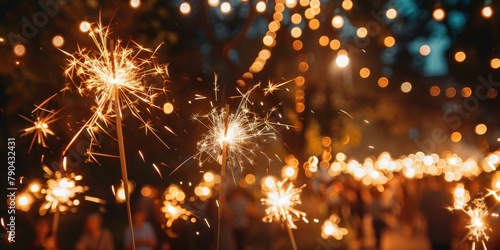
<box><xmin>124</xmin><ymin>209</ymin><xmax>158</xmax><ymax>250</ymax></box>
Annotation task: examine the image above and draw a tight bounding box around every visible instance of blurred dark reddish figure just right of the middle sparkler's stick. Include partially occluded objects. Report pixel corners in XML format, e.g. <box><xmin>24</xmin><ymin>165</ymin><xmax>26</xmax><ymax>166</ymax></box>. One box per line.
<box><xmin>227</xmin><ymin>187</ymin><xmax>255</xmax><ymax>250</ymax></box>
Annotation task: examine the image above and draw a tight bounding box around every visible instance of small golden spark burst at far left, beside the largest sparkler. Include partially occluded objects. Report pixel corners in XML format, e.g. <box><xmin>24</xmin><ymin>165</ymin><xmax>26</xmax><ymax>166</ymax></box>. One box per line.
<box><xmin>19</xmin><ymin>94</ymin><xmax>61</xmax><ymax>153</ymax></box>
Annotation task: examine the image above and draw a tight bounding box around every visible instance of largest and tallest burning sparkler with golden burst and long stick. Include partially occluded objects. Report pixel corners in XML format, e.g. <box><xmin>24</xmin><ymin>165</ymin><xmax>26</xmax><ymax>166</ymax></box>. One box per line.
<box><xmin>63</xmin><ymin>19</ymin><xmax>168</xmax><ymax>249</ymax></box>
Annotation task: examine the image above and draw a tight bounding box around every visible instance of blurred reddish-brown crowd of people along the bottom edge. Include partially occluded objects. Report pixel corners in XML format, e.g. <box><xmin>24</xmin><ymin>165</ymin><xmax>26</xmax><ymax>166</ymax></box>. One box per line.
<box><xmin>25</xmin><ymin>177</ymin><xmax>500</xmax><ymax>250</ymax></box>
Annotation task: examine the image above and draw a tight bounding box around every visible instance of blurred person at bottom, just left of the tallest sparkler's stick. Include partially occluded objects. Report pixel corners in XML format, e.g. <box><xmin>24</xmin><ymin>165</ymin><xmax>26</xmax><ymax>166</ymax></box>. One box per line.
<box><xmin>75</xmin><ymin>213</ymin><xmax>115</xmax><ymax>250</ymax></box>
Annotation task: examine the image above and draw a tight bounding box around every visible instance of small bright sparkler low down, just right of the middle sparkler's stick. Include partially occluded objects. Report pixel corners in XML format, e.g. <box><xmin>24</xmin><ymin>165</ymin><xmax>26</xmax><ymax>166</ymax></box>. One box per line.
<box><xmin>261</xmin><ymin>177</ymin><xmax>308</xmax><ymax>250</ymax></box>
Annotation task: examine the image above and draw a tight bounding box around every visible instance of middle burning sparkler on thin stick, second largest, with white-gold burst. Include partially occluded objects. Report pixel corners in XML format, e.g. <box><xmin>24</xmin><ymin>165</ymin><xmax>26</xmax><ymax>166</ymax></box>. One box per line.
<box><xmin>188</xmin><ymin>81</ymin><xmax>288</xmax><ymax>249</ymax></box>
